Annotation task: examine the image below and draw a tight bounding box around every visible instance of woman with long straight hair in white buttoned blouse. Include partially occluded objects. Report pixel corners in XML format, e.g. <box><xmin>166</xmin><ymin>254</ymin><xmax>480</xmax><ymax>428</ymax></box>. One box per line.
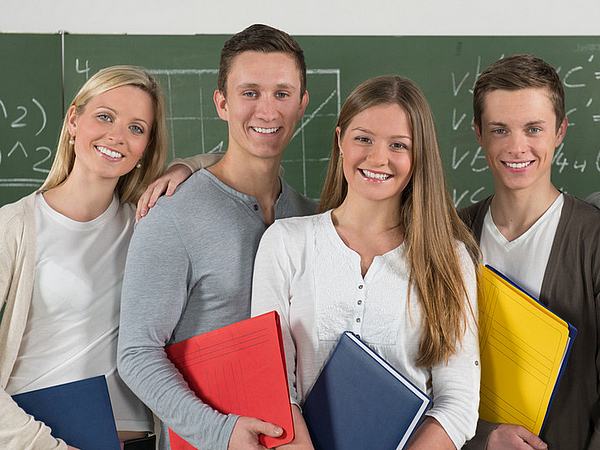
<box><xmin>252</xmin><ymin>76</ymin><xmax>480</xmax><ymax>449</ymax></box>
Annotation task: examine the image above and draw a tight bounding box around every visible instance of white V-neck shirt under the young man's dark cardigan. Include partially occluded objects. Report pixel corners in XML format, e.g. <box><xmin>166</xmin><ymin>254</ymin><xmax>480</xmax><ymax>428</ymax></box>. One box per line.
<box><xmin>480</xmin><ymin>194</ymin><xmax>565</xmax><ymax>298</ymax></box>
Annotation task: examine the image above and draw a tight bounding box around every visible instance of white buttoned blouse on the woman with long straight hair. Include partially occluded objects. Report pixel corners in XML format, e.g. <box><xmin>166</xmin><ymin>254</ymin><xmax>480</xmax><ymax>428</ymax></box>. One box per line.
<box><xmin>252</xmin><ymin>212</ymin><xmax>480</xmax><ymax>448</ymax></box>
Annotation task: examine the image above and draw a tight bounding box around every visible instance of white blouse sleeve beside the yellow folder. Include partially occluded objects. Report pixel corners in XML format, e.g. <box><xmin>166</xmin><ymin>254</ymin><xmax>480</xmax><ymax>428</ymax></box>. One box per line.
<box><xmin>427</xmin><ymin>245</ymin><xmax>481</xmax><ymax>449</ymax></box>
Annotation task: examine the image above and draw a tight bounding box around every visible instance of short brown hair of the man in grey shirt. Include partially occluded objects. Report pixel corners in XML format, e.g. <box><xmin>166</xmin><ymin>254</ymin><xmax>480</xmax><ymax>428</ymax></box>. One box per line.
<box><xmin>218</xmin><ymin>24</ymin><xmax>306</xmax><ymax>97</ymax></box>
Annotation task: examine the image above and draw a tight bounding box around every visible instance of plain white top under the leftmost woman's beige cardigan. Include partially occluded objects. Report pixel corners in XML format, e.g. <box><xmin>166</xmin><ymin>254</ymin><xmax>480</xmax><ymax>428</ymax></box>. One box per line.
<box><xmin>6</xmin><ymin>194</ymin><xmax>153</xmax><ymax>431</ymax></box>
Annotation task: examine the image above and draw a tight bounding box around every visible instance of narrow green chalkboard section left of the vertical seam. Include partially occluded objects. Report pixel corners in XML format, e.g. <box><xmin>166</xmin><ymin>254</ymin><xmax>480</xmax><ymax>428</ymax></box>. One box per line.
<box><xmin>0</xmin><ymin>34</ymin><xmax>62</xmax><ymax>205</ymax></box>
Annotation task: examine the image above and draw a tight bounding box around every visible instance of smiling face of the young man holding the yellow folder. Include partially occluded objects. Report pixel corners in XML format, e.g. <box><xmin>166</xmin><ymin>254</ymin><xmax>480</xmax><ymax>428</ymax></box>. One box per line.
<box><xmin>475</xmin><ymin>88</ymin><xmax>567</xmax><ymax>192</ymax></box>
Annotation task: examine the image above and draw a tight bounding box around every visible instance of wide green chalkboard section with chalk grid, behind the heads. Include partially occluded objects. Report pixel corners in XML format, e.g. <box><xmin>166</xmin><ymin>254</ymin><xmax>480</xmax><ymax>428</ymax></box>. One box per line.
<box><xmin>0</xmin><ymin>35</ymin><xmax>600</xmax><ymax>206</ymax></box>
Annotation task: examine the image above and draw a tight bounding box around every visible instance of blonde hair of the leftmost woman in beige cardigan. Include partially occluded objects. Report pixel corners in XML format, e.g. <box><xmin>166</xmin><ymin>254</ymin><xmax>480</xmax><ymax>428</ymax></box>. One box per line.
<box><xmin>40</xmin><ymin>66</ymin><xmax>168</xmax><ymax>203</ymax></box>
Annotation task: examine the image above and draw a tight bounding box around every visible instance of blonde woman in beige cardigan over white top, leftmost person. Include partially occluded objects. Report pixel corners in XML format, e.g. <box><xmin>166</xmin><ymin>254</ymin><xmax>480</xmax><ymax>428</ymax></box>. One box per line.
<box><xmin>0</xmin><ymin>66</ymin><xmax>167</xmax><ymax>450</ymax></box>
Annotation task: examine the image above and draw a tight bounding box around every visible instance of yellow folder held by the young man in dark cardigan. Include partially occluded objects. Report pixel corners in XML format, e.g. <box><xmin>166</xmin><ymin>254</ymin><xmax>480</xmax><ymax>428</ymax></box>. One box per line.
<box><xmin>478</xmin><ymin>266</ymin><xmax>577</xmax><ymax>435</ymax></box>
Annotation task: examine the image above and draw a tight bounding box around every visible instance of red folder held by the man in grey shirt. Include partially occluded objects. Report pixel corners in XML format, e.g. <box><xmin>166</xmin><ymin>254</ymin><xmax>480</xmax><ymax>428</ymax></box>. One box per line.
<box><xmin>165</xmin><ymin>311</ymin><xmax>294</xmax><ymax>450</ymax></box>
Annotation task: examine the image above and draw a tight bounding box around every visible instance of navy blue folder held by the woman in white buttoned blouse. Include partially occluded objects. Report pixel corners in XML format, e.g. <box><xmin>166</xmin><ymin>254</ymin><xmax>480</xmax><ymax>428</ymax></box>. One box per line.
<box><xmin>302</xmin><ymin>331</ymin><xmax>431</xmax><ymax>450</ymax></box>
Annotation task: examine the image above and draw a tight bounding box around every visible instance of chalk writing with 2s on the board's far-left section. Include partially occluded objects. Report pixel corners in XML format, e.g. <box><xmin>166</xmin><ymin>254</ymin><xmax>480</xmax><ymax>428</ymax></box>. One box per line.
<box><xmin>0</xmin><ymin>97</ymin><xmax>52</xmax><ymax>187</ymax></box>
